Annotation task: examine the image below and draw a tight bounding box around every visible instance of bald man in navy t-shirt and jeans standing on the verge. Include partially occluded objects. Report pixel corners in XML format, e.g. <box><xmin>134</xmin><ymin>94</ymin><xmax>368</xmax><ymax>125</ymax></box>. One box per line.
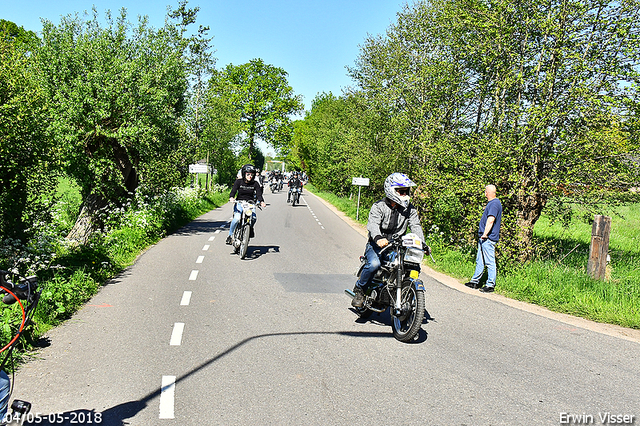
<box><xmin>465</xmin><ymin>185</ymin><xmax>502</xmax><ymax>293</ymax></box>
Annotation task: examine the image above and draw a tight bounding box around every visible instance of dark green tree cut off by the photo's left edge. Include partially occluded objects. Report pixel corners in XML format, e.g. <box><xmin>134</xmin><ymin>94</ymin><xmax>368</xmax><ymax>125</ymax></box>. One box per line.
<box><xmin>0</xmin><ymin>25</ymin><xmax>57</xmax><ymax>242</ymax></box>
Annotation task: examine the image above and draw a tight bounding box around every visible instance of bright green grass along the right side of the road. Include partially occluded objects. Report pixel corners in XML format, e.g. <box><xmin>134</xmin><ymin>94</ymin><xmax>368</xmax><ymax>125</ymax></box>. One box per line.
<box><xmin>308</xmin><ymin>185</ymin><xmax>640</xmax><ymax>329</ymax></box>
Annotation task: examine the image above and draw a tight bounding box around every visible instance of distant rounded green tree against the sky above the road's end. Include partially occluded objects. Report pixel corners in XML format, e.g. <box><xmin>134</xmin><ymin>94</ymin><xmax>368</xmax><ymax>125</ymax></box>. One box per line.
<box><xmin>222</xmin><ymin>59</ymin><xmax>304</xmax><ymax>159</ymax></box>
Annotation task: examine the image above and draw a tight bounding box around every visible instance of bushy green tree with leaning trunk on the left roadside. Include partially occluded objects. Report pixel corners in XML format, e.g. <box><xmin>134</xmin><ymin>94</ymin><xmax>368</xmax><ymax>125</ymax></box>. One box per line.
<box><xmin>38</xmin><ymin>2</ymin><xmax>201</xmax><ymax>242</ymax></box>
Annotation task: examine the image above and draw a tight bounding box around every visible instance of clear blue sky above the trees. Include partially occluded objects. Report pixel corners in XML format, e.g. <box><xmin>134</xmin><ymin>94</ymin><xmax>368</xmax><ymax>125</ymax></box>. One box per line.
<box><xmin>0</xmin><ymin>0</ymin><xmax>406</xmax><ymax>113</ymax></box>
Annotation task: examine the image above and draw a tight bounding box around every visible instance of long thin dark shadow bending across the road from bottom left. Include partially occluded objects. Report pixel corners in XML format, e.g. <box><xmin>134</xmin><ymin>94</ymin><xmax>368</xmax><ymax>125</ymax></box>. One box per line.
<box><xmin>21</xmin><ymin>331</ymin><xmax>396</xmax><ymax>426</ymax></box>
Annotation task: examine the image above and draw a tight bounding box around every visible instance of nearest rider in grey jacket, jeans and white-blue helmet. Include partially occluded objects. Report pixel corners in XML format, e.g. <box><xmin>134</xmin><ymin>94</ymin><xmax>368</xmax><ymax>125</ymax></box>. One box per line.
<box><xmin>351</xmin><ymin>173</ymin><xmax>424</xmax><ymax>308</ymax></box>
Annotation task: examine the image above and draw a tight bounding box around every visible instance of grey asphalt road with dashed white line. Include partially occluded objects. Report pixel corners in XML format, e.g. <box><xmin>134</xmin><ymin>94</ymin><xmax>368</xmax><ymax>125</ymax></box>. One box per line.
<box><xmin>12</xmin><ymin>191</ymin><xmax>640</xmax><ymax>426</ymax></box>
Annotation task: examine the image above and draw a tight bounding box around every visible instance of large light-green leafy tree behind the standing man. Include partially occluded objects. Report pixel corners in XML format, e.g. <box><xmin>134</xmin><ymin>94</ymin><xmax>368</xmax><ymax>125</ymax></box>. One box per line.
<box><xmin>344</xmin><ymin>0</ymin><xmax>640</xmax><ymax>260</ymax></box>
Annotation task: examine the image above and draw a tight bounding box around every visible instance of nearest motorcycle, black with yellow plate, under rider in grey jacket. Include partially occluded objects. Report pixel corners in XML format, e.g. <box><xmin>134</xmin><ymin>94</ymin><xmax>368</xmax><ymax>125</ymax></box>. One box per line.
<box><xmin>345</xmin><ymin>234</ymin><xmax>430</xmax><ymax>342</ymax></box>
